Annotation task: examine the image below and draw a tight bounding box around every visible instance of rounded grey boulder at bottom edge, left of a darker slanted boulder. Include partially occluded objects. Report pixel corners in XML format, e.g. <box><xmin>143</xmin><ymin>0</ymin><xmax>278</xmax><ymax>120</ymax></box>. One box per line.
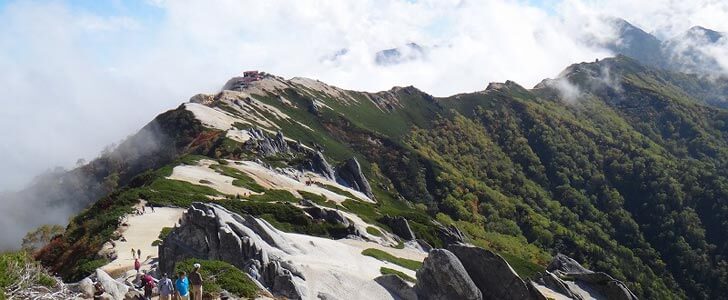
<box><xmin>415</xmin><ymin>249</ymin><xmax>483</xmax><ymax>300</ymax></box>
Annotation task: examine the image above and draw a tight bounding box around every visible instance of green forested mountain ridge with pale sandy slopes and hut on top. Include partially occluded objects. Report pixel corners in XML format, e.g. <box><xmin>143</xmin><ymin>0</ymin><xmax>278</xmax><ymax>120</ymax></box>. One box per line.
<box><xmin>38</xmin><ymin>57</ymin><xmax>728</xmax><ymax>299</ymax></box>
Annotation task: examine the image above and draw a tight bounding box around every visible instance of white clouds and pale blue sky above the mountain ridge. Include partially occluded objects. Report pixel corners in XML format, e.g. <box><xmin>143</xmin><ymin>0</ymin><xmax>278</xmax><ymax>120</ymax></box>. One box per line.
<box><xmin>0</xmin><ymin>0</ymin><xmax>728</xmax><ymax>190</ymax></box>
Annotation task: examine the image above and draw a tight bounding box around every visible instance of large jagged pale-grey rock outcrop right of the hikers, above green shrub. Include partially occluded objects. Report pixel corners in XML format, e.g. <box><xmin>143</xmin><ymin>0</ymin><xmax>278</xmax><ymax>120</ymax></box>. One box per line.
<box><xmin>159</xmin><ymin>203</ymin><xmax>304</xmax><ymax>299</ymax></box>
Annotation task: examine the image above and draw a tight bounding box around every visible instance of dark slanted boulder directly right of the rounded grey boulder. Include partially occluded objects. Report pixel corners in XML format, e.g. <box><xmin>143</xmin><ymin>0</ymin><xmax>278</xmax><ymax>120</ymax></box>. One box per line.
<box><xmin>447</xmin><ymin>245</ymin><xmax>530</xmax><ymax>300</ymax></box>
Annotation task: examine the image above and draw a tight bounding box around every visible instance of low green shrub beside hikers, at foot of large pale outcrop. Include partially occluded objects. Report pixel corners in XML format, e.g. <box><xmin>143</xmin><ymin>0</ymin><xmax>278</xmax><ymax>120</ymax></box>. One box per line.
<box><xmin>175</xmin><ymin>259</ymin><xmax>258</xmax><ymax>299</ymax></box>
